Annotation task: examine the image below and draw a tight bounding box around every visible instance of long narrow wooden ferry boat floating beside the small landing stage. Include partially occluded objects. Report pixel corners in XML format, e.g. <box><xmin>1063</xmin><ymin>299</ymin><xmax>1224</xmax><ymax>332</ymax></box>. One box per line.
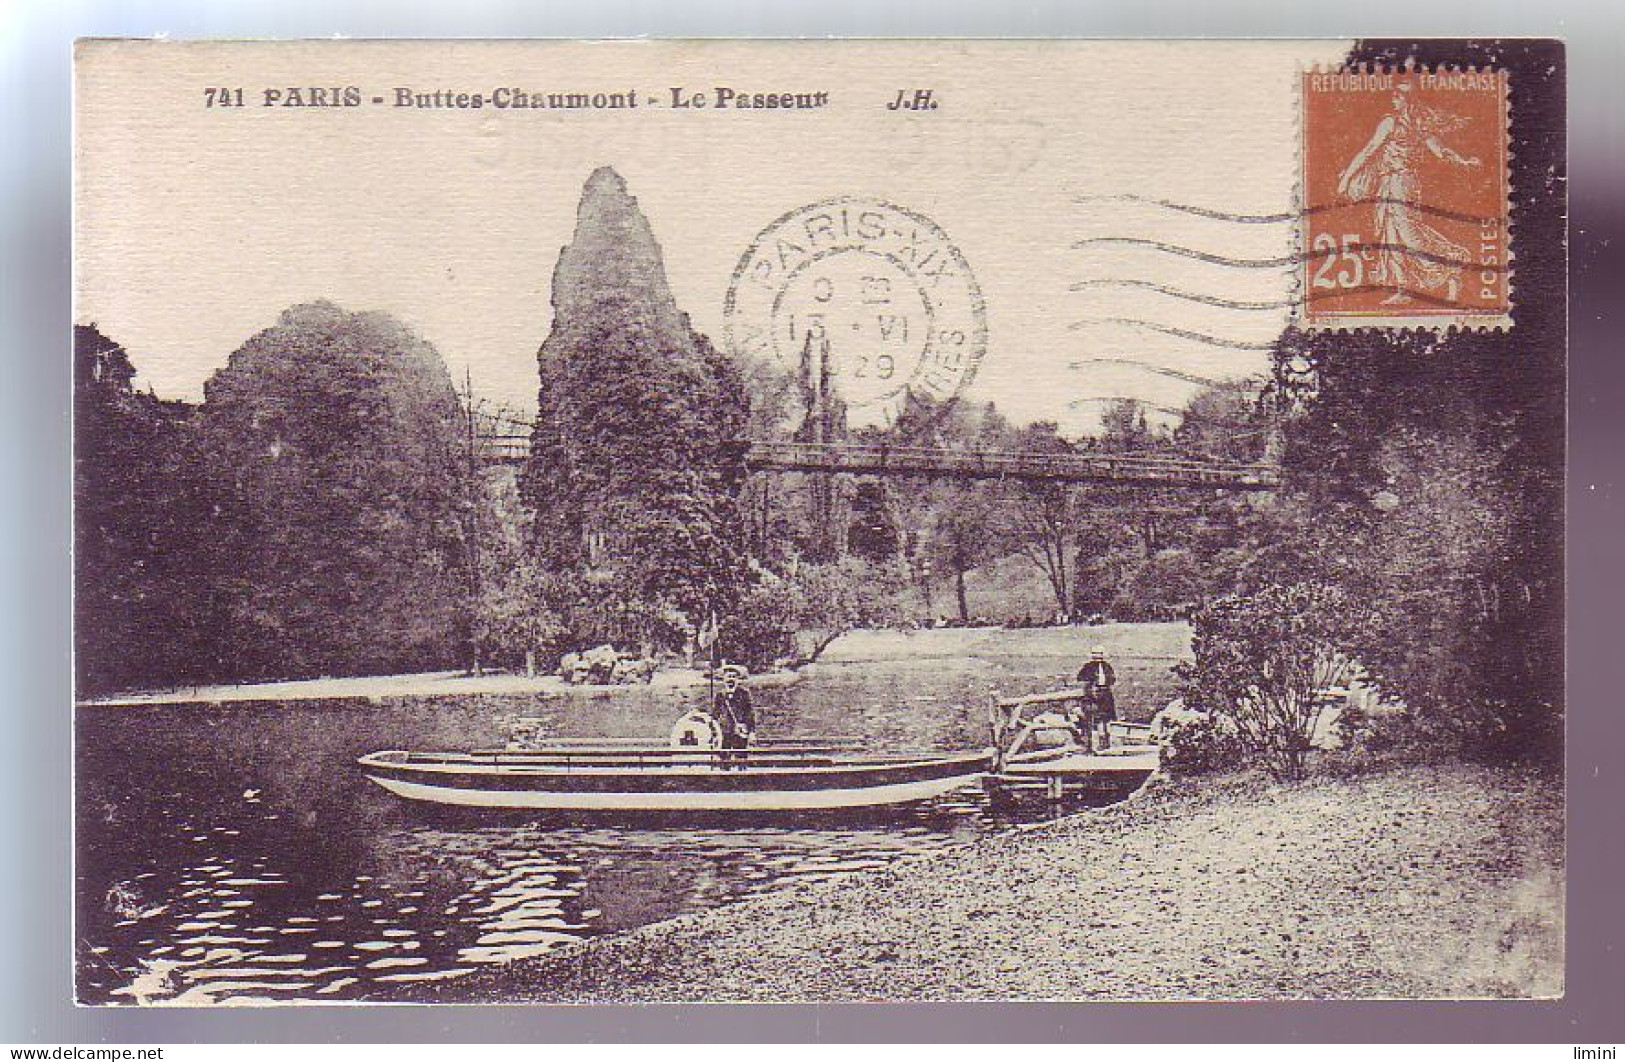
<box><xmin>358</xmin><ymin>742</ymin><xmax>993</xmax><ymax>814</ymax></box>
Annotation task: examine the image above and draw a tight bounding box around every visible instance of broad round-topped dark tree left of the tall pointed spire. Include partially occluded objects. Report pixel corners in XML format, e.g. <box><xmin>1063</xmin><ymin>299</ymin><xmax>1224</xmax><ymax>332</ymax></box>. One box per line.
<box><xmin>198</xmin><ymin>302</ymin><xmax>471</xmax><ymax>677</ymax></box>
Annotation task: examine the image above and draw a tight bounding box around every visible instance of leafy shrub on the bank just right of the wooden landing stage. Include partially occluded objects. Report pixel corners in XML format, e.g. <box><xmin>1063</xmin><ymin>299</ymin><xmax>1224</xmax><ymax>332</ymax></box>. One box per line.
<box><xmin>1180</xmin><ymin>583</ymin><xmax>1368</xmax><ymax>778</ymax></box>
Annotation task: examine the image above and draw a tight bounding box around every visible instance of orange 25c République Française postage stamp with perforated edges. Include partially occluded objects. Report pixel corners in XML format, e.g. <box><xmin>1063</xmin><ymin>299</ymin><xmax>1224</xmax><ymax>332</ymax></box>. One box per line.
<box><xmin>1298</xmin><ymin>68</ymin><xmax>1513</xmax><ymax>328</ymax></box>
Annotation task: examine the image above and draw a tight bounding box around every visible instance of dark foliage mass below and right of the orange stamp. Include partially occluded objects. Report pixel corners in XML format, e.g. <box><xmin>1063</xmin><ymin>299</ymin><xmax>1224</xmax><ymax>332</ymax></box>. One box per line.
<box><xmin>1264</xmin><ymin>41</ymin><xmax>1567</xmax><ymax>753</ymax></box>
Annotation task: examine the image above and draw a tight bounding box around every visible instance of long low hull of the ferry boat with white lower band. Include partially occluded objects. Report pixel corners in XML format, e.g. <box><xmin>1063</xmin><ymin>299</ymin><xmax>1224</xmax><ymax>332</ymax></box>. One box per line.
<box><xmin>361</xmin><ymin>753</ymin><xmax>990</xmax><ymax>814</ymax></box>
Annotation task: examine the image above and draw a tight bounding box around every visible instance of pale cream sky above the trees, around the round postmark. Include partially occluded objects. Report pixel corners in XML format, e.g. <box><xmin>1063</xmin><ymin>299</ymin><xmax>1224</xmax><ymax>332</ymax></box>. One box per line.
<box><xmin>75</xmin><ymin>41</ymin><xmax>1347</xmax><ymax>432</ymax></box>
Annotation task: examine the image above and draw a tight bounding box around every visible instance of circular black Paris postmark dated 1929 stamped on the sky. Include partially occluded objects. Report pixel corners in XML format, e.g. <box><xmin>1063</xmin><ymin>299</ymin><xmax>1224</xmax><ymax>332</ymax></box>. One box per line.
<box><xmin>723</xmin><ymin>196</ymin><xmax>988</xmax><ymax>424</ymax></box>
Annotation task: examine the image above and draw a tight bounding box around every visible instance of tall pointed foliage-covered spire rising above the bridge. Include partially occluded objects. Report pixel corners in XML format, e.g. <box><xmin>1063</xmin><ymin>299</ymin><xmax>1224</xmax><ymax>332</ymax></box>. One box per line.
<box><xmin>520</xmin><ymin>169</ymin><xmax>749</xmax><ymax>651</ymax></box>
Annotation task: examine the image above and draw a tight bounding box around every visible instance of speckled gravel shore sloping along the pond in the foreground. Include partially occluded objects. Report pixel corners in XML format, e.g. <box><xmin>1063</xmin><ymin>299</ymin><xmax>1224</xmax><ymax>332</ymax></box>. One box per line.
<box><xmin>429</xmin><ymin>765</ymin><xmax>1563</xmax><ymax>1002</ymax></box>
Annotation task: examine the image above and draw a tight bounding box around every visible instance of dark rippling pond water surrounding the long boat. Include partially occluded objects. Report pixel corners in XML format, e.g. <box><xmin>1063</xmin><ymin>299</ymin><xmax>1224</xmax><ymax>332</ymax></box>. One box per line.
<box><xmin>76</xmin><ymin>625</ymin><xmax>1188</xmax><ymax>1004</ymax></box>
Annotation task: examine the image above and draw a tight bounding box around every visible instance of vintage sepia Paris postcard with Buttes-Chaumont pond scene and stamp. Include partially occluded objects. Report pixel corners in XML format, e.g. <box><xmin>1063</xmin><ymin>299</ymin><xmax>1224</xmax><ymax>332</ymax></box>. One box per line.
<box><xmin>73</xmin><ymin>39</ymin><xmax>1567</xmax><ymax>1007</ymax></box>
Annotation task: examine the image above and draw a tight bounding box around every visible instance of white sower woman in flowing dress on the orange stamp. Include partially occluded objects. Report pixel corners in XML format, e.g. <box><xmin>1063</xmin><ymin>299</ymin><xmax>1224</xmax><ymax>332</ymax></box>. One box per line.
<box><xmin>1337</xmin><ymin>84</ymin><xmax>1479</xmax><ymax>304</ymax></box>
